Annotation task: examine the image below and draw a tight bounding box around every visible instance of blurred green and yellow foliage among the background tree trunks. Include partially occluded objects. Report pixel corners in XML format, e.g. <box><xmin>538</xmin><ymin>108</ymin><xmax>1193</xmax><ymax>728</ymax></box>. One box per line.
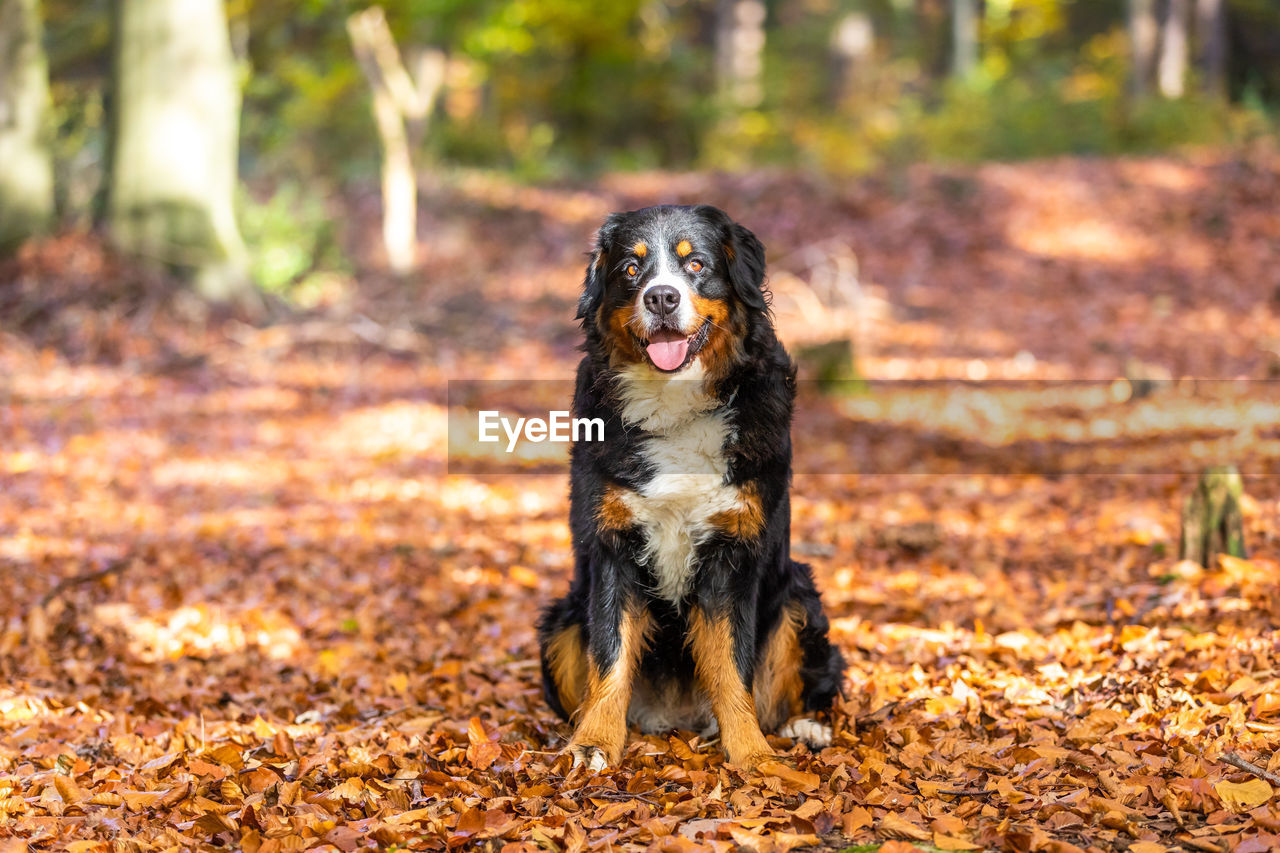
<box><xmin>27</xmin><ymin>0</ymin><xmax>1280</xmax><ymax>289</ymax></box>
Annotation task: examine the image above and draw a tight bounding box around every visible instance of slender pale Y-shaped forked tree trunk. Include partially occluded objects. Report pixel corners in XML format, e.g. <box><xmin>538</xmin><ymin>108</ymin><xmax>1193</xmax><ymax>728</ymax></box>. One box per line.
<box><xmin>347</xmin><ymin>6</ymin><xmax>445</xmax><ymax>275</ymax></box>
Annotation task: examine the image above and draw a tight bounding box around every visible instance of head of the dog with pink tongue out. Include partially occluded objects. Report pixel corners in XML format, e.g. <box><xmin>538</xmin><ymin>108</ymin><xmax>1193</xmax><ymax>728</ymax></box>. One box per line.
<box><xmin>577</xmin><ymin>205</ymin><xmax>768</xmax><ymax>374</ymax></box>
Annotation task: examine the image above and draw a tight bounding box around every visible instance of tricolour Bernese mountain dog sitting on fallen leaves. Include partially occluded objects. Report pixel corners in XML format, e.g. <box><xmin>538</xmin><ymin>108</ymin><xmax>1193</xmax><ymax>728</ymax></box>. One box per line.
<box><xmin>538</xmin><ymin>205</ymin><xmax>845</xmax><ymax>770</ymax></box>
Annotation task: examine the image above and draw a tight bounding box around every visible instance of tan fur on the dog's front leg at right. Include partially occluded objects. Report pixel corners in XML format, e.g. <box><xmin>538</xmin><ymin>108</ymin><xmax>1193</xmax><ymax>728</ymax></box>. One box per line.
<box><xmin>689</xmin><ymin>607</ymin><xmax>773</xmax><ymax>767</ymax></box>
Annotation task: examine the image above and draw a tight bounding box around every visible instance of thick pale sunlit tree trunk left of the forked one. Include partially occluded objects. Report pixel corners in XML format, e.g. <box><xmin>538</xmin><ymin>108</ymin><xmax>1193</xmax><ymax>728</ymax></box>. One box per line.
<box><xmin>108</xmin><ymin>0</ymin><xmax>253</xmax><ymax>302</ymax></box>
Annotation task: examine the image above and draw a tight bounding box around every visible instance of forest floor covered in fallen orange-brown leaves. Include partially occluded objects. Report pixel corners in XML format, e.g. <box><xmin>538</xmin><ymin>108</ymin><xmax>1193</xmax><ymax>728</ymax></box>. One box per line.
<box><xmin>0</xmin><ymin>151</ymin><xmax>1280</xmax><ymax>853</ymax></box>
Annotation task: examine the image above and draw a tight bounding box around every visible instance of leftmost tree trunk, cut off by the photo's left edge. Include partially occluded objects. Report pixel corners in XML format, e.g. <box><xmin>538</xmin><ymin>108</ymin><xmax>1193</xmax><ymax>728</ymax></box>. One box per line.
<box><xmin>0</xmin><ymin>0</ymin><xmax>54</xmax><ymax>254</ymax></box>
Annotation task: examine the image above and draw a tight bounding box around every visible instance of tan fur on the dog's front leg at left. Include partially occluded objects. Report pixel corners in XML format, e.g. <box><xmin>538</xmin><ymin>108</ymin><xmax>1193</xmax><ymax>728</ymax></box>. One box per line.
<box><xmin>568</xmin><ymin>610</ymin><xmax>652</xmax><ymax>765</ymax></box>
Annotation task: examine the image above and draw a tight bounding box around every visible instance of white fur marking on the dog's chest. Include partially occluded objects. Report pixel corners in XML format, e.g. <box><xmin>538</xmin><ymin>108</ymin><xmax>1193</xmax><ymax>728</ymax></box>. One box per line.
<box><xmin>611</xmin><ymin>360</ymin><xmax>739</xmax><ymax>602</ymax></box>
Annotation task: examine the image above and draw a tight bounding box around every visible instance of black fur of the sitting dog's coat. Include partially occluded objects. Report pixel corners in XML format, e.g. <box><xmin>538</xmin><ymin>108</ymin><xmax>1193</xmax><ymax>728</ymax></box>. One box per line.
<box><xmin>538</xmin><ymin>205</ymin><xmax>845</xmax><ymax>753</ymax></box>
